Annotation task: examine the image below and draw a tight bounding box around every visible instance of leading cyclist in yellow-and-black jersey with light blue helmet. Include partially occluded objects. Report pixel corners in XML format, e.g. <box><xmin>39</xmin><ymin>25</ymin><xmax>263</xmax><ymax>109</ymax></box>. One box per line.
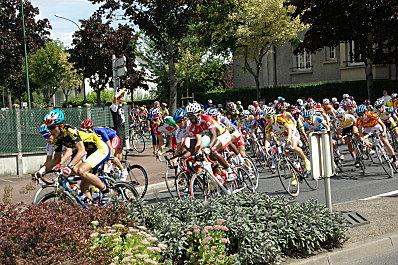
<box><xmin>44</xmin><ymin>109</ymin><xmax>110</xmax><ymax>200</ymax></box>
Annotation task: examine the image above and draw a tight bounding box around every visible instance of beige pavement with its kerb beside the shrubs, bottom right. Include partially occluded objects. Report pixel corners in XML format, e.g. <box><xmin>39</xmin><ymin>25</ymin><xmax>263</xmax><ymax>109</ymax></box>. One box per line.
<box><xmin>284</xmin><ymin>196</ymin><xmax>398</xmax><ymax>265</ymax></box>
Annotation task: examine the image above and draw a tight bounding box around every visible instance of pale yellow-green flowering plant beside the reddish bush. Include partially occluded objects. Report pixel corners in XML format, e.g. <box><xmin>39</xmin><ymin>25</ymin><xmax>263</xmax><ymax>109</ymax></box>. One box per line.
<box><xmin>90</xmin><ymin>222</ymin><xmax>167</xmax><ymax>265</ymax></box>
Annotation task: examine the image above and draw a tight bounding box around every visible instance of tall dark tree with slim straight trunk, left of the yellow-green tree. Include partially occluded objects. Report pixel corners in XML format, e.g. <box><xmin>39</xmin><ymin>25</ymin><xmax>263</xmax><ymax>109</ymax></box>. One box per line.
<box><xmin>90</xmin><ymin>0</ymin><xmax>208</xmax><ymax>112</ymax></box>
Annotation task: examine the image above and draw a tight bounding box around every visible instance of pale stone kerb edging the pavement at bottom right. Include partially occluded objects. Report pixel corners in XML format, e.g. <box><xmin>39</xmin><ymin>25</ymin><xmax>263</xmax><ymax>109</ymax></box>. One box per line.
<box><xmin>285</xmin><ymin>232</ymin><xmax>398</xmax><ymax>265</ymax></box>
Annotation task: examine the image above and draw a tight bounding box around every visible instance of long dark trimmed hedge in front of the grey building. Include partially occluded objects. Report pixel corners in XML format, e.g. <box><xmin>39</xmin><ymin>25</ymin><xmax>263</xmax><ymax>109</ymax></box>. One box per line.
<box><xmin>195</xmin><ymin>80</ymin><xmax>398</xmax><ymax>106</ymax></box>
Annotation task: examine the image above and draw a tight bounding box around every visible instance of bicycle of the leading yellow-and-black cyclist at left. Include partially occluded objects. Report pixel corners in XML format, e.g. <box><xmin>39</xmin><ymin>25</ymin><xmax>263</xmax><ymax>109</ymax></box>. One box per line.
<box><xmin>33</xmin><ymin>172</ymin><xmax>138</xmax><ymax>208</ymax></box>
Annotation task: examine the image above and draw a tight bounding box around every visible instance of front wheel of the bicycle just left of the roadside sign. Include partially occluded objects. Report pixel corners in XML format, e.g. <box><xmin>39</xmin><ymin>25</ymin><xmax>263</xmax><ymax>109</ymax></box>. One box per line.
<box><xmin>277</xmin><ymin>158</ymin><xmax>300</xmax><ymax>197</ymax></box>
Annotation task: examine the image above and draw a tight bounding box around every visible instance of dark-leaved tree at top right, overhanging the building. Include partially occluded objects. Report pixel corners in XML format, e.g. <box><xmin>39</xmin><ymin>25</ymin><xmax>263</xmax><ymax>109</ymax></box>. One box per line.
<box><xmin>290</xmin><ymin>0</ymin><xmax>398</xmax><ymax>99</ymax></box>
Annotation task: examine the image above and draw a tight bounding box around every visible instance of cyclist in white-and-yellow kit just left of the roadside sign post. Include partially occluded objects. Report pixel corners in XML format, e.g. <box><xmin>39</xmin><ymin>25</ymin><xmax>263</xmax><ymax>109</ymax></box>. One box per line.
<box><xmin>264</xmin><ymin>107</ymin><xmax>311</xmax><ymax>182</ymax></box>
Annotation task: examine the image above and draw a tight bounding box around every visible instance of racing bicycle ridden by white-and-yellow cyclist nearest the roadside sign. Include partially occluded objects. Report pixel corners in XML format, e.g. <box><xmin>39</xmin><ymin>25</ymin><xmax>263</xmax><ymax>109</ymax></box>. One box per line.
<box><xmin>276</xmin><ymin>142</ymin><xmax>319</xmax><ymax>197</ymax></box>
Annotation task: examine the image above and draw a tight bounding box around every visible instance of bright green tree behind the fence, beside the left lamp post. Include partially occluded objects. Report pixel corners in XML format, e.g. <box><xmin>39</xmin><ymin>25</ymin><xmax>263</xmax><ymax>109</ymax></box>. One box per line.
<box><xmin>29</xmin><ymin>41</ymin><xmax>75</xmax><ymax>104</ymax></box>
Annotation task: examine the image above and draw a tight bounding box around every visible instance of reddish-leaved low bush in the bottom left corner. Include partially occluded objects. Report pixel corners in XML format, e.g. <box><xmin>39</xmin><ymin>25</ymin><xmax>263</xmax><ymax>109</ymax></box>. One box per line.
<box><xmin>0</xmin><ymin>201</ymin><xmax>135</xmax><ymax>265</ymax></box>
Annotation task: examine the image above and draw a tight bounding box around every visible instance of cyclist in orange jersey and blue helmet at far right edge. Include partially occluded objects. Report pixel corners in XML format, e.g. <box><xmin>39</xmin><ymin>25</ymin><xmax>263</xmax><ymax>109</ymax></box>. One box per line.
<box><xmin>356</xmin><ymin>105</ymin><xmax>397</xmax><ymax>164</ymax></box>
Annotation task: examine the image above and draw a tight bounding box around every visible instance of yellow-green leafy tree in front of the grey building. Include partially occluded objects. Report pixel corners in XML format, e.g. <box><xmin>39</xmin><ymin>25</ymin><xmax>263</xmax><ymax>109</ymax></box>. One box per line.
<box><xmin>233</xmin><ymin>0</ymin><xmax>306</xmax><ymax>100</ymax></box>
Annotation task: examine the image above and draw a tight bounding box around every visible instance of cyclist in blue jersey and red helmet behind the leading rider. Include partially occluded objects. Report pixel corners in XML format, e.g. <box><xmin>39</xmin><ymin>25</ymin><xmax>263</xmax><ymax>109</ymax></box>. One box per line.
<box><xmin>80</xmin><ymin>119</ymin><xmax>128</xmax><ymax>180</ymax></box>
